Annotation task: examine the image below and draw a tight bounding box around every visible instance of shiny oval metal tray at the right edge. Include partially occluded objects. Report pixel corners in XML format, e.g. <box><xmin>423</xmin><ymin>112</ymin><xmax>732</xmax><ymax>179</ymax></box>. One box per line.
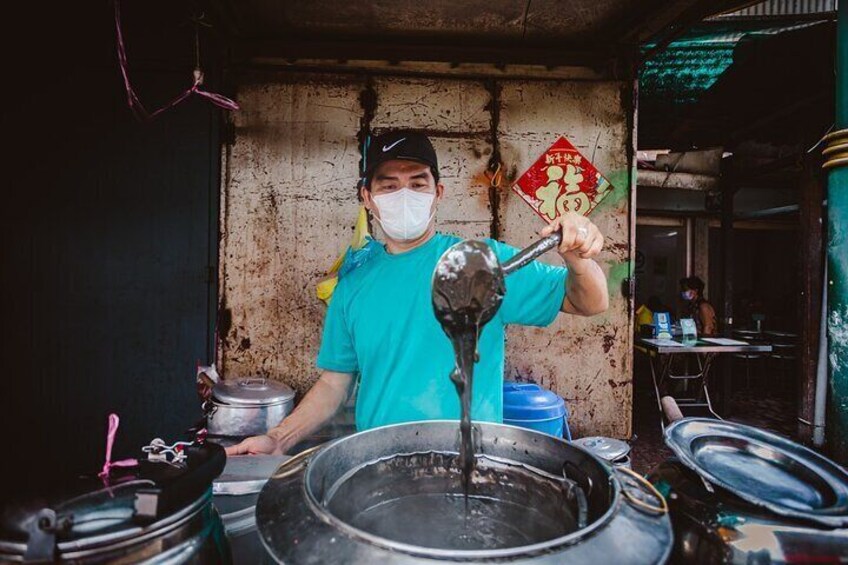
<box><xmin>665</xmin><ymin>418</ymin><xmax>848</xmax><ymax>527</ymax></box>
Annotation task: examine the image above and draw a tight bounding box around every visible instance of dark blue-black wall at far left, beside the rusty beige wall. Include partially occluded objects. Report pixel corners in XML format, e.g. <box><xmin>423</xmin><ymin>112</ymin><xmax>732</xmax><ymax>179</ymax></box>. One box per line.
<box><xmin>0</xmin><ymin>2</ymin><xmax>220</xmax><ymax>484</ymax></box>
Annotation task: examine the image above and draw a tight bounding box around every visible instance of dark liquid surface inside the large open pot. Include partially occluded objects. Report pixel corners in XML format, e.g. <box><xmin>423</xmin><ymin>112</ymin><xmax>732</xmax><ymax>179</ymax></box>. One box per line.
<box><xmin>325</xmin><ymin>452</ymin><xmax>578</xmax><ymax>550</ymax></box>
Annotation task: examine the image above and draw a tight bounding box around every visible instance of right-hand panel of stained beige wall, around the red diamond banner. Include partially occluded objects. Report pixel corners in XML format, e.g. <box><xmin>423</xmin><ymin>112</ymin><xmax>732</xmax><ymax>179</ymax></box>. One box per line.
<box><xmin>499</xmin><ymin>81</ymin><xmax>633</xmax><ymax>437</ymax></box>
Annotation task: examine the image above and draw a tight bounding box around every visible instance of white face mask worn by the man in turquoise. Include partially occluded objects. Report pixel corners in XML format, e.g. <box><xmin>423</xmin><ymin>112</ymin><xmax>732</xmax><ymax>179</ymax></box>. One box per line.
<box><xmin>374</xmin><ymin>188</ymin><xmax>436</xmax><ymax>241</ymax></box>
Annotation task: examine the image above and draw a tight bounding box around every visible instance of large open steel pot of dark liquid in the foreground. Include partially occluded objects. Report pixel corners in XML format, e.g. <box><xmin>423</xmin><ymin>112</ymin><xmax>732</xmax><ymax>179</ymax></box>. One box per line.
<box><xmin>256</xmin><ymin>421</ymin><xmax>672</xmax><ymax>565</ymax></box>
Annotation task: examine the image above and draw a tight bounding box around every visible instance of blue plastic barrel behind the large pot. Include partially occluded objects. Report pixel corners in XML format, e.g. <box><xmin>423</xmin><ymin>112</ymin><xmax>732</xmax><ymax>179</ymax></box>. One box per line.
<box><xmin>504</xmin><ymin>381</ymin><xmax>571</xmax><ymax>441</ymax></box>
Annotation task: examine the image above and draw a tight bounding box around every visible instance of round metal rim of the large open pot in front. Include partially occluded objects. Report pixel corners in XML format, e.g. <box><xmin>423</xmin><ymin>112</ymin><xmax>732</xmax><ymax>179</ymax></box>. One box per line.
<box><xmin>302</xmin><ymin>420</ymin><xmax>622</xmax><ymax>560</ymax></box>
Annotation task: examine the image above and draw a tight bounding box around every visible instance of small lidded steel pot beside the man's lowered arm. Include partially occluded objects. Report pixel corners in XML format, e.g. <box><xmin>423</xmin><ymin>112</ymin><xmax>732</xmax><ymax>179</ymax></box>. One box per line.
<box><xmin>204</xmin><ymin>378</ymin><xmax>294</xmax><ymax>437</ymax></box>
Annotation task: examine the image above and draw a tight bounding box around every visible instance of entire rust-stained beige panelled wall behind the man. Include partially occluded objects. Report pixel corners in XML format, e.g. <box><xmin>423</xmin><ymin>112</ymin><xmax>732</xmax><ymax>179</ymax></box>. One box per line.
<box><xmin>219</xmin><ymin>66</ymin><xmax>632</xmax><ymax>437</ymax></box>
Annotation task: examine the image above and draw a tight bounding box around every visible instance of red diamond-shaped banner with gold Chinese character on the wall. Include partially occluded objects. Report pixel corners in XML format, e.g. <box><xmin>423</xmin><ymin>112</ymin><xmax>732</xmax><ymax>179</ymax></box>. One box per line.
<box><xmin>512</xmin><ymin>137</ymin><xmax>612</xmax><ymax>221</ymax></box>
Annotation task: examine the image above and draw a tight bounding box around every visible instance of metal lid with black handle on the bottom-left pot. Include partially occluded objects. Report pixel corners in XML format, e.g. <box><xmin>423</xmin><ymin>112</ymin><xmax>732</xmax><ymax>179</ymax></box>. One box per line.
<box><xmin>0</xmin><ymin>443</ymin><xmax>226</xmax><ymax>563</ymax></box>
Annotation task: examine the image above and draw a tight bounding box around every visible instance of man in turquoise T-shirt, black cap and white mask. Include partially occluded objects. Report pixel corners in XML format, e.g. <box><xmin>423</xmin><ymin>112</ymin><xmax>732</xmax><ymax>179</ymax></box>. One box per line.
<box><xmin>227</xmin><ymin>131</ymin><xmax>609</xmax><ymax>455</ymax></box>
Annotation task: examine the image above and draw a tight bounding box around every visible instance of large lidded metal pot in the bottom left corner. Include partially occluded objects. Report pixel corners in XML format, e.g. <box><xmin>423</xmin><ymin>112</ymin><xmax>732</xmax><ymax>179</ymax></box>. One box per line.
<box><xmin>0</xmin><ymin>444</ymin><xmax>231</xmax><ymax>565</ymax></box>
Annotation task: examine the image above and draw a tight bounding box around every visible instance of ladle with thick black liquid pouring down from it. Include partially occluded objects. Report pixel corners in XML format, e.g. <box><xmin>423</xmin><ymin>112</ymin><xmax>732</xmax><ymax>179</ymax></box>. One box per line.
<box><xmin>433</xmin><ymin>232</ymin><xmax>562</xmax><ymax>498</ymax></box>
